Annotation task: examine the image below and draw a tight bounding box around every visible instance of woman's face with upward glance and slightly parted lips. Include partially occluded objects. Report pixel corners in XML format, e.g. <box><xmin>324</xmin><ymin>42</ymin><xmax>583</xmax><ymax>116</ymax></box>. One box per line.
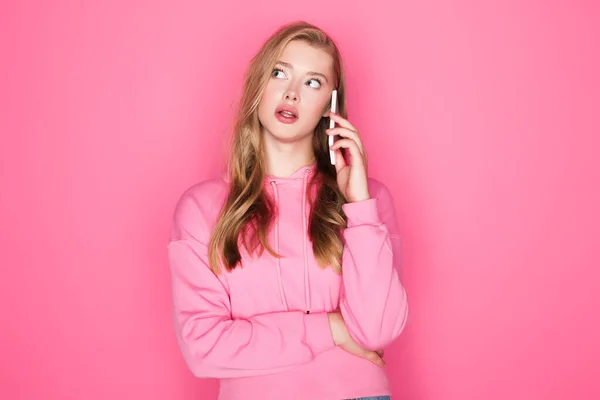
<box><xmin>258</xmin><ymin>40</ymin><xmax>334</xmax><ymax>142</ymax></box>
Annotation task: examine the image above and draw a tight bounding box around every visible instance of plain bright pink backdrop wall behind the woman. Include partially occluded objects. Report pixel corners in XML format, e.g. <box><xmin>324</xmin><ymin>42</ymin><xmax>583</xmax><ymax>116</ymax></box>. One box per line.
<box><xmin>0</xmin><ymin>0</ymin><xmax>600</xmax><ymax>400</ymax></box>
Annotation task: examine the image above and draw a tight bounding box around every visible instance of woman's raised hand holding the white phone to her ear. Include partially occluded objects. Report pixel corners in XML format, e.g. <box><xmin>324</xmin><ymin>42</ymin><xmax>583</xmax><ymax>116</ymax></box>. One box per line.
<box><xmin>326</xmin><ymin>113</ymin><xmax>371</xmax><ymax>203</ymax></box>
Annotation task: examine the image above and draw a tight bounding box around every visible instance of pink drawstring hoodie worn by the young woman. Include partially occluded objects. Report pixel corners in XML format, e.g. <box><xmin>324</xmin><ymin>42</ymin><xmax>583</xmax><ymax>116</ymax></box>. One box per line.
<box><xmin>168</xmin><ymin>164</ymin><xmax>408</xmax><ymax>400</ymax></box>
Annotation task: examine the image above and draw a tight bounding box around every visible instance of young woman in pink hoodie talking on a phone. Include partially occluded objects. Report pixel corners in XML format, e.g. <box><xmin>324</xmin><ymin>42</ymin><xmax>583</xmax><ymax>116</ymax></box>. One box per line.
<box><xmin>168</xmin><ymin>22</ymin><xmax>408</xmax><ymax>400</ymax></box>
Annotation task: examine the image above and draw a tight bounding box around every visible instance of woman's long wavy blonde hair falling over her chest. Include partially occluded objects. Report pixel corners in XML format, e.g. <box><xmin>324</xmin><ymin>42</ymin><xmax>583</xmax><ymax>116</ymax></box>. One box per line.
<box><xmin>208</xmin><ymin>21</ymin><xmax>347</xmax><ymax>274</ymax></box>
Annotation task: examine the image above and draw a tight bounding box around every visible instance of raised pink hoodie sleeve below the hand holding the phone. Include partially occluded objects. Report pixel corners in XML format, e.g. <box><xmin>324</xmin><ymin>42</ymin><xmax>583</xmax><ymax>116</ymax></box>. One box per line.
<box><xmin>340</xmin><ymin>180</ymin><xmax>408</xmax><ymax>350</ymax></box>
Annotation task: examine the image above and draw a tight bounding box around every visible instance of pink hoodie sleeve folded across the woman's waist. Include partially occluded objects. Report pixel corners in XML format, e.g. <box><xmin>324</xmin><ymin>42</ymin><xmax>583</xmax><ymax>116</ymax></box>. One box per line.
<box><xmin>168</xmin><ymin>191</ymin><xmax>335</xmax><ymax>378</ymax></box>
